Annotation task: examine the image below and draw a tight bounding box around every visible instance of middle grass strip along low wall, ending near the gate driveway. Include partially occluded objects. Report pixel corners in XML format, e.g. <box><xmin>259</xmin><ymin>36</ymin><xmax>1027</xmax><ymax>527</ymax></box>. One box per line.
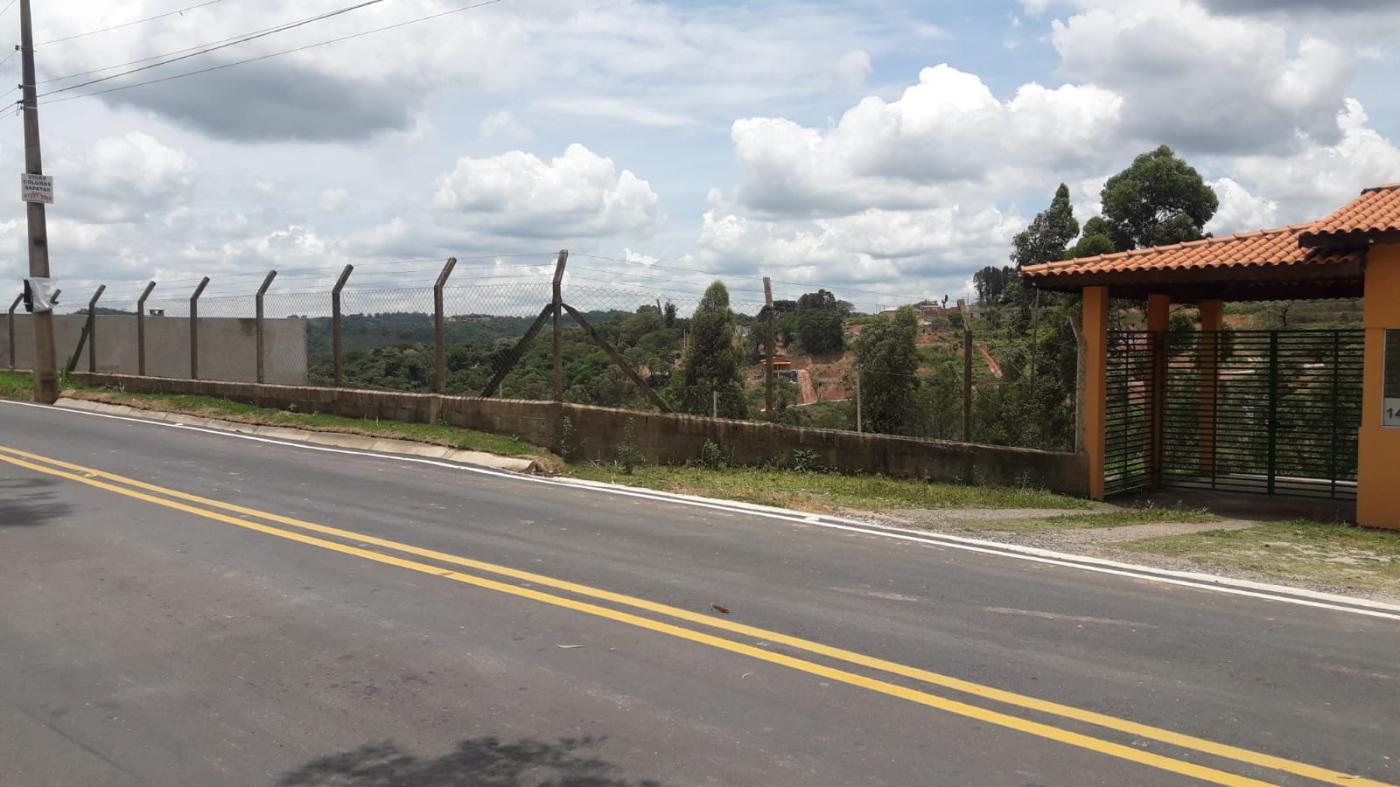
<box><xmin>567</xmin><ymin>462</ymin><xmax>1089</xmax><ymax>513</ymax></box>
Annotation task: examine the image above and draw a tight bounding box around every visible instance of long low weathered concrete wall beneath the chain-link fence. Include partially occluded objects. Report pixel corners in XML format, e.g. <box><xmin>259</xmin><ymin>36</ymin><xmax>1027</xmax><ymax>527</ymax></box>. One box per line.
<box><xmin>74</xmin><ymin>374</ymin><xmax>1088</xmax><ymax>496</ymax></box>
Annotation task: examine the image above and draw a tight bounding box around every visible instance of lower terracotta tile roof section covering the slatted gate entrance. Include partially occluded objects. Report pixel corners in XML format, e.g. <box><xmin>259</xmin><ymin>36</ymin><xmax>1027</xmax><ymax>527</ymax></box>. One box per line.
<box><xmin>1021</xmin><ymin>224</ymin><xmax>1365</xmax><ymax>284</ymax></box>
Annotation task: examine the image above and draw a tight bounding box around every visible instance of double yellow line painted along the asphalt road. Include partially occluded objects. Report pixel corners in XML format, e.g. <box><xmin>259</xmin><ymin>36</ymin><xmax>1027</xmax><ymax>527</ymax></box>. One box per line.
<box><xmin>0</xmin><ymin>445</ymin><xmax>1382</xmax><ymax>786</ymax></box>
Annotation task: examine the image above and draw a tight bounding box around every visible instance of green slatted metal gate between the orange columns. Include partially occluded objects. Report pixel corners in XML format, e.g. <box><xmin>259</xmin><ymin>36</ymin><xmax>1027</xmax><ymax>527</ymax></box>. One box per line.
<box><xmin>1105</xmin><ymin>324</ymin><xmax>1364</xmax><ymax>500</ymax></box>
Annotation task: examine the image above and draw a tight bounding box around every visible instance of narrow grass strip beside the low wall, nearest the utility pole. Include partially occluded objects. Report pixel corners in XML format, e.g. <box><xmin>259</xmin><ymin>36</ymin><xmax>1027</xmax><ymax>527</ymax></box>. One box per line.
<box><xmin>69</xmin><ymin>389</ymin><xmax>559</xmax><ymax>468</ymax></box>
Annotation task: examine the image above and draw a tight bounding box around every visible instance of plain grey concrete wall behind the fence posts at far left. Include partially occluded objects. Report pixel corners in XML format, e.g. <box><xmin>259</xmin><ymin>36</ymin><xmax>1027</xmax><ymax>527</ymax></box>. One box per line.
<box><xmin>0</xmin><ymin>314</ymin><xmax>307</xmax><ymax>385</ymax></box>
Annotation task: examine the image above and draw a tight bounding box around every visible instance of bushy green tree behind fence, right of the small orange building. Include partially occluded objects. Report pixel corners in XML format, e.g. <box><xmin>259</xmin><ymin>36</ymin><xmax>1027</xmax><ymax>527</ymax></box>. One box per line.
<box><xmin>855</xmin><ymin>307</ymin><xmax>918</xmax><ymax>434</ymax></box>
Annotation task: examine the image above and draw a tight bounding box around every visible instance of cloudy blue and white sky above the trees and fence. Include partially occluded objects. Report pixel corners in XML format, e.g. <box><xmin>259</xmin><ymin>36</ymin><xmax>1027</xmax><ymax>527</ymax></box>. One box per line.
<box><xmin>0</xmin><ymin>0</ymin><xmax>1400</xmax><ymax>307</ymax></box>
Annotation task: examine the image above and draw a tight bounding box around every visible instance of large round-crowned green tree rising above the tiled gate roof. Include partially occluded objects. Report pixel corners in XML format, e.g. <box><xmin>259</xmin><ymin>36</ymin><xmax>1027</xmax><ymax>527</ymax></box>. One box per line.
<box><xmin>1100</xmin><ymin>144</ymin><xmax>1219</xmax><ymax>251</ymax></box>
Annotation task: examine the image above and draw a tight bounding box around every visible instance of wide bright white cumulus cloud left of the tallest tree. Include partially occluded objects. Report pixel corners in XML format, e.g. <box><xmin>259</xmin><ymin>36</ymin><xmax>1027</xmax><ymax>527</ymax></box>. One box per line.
<box><xmin>731</xmin><ymin>64</ymin><xmax>1121</xmax><ymax>214</ymax></box>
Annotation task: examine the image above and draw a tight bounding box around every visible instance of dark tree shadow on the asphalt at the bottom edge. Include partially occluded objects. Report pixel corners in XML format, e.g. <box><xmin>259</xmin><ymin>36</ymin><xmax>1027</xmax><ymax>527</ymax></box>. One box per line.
<box><xmin>279</xmin><ymin>738</ymin><xmax>661</xmax><ymax>787</ymax></box>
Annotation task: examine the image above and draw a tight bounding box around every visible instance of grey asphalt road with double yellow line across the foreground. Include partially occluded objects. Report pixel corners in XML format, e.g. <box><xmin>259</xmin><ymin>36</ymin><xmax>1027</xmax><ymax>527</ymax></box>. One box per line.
<box><xmin>0</xmin><ymin>403</ymin><xmax>1400</xmax><ymax>786</ymax></box>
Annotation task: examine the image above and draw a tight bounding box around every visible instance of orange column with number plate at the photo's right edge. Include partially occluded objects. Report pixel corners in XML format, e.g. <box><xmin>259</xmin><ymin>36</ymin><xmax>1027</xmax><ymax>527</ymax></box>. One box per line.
<box><xmin>1357</xmin><ymin>244</ymin><xmax>1400</xmax><ymax>529</ymax></box>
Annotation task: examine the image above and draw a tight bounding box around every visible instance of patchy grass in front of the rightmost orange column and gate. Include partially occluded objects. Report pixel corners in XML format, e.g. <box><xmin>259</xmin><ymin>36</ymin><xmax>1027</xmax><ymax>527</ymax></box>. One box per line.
<box><xmin>1119</xmin><ymin>521</ymin><xmax>1400</xmax><ymax>594</ymax></box>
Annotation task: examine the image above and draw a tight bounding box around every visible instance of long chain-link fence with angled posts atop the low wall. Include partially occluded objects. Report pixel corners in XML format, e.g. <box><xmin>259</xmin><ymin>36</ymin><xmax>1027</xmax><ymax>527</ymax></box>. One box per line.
<box><xmin>7</xmin><ymin>253</ymin><xmax>1078</xmax><ymax>450</ymax></box>
